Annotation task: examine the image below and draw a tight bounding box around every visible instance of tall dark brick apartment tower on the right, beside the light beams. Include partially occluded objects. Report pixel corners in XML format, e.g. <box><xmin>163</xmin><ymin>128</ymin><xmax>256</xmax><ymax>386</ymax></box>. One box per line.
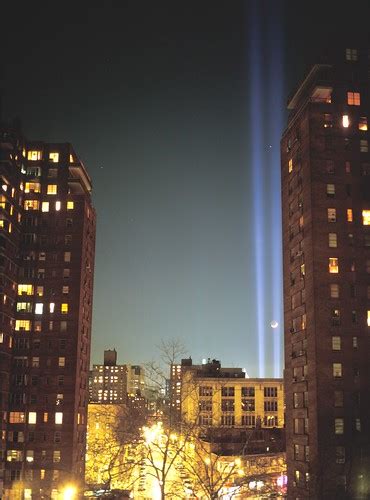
<box><xmin>281</xmin><ymin>49</ymin><xmax>370</xmax><ymax>499</ymax></box>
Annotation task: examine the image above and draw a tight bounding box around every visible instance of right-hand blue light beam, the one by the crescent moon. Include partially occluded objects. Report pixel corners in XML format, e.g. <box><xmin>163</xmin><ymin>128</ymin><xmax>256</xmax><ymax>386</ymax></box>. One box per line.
<box><xmin>268</xmin><ymin>2</ymin><xmax>284</xmax><ymax>377</ymax></box>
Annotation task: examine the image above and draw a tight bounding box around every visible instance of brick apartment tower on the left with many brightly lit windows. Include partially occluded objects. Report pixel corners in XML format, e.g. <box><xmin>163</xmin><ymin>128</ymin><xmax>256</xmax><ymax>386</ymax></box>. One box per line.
<box><xmin>0</xmin><ymin>122</ymin><xmax>95</xmax><ymax>499</ymax></box>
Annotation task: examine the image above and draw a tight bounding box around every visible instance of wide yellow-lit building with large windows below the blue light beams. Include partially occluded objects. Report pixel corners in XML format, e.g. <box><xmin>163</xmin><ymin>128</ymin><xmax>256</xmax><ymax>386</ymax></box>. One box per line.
<box><xmin>181</xmin><ymin>360</ymin><xmax>284</xmax><ymax>429</ymax></box>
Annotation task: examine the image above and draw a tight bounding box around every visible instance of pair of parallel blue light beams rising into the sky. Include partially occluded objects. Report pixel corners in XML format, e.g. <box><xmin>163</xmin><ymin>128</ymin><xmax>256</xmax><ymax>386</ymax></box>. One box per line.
<box><xmin>248</xmin><ymin>0</ymin><xmax>284</xmax><ymax>377</ymax></box>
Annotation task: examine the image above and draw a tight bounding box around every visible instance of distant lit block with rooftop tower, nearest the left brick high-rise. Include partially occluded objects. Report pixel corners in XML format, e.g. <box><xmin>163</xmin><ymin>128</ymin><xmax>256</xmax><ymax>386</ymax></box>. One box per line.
<box><xmin>90</xmin><ymin>349</ymin><xmax>128</xmax><ymax>404</ymax></box>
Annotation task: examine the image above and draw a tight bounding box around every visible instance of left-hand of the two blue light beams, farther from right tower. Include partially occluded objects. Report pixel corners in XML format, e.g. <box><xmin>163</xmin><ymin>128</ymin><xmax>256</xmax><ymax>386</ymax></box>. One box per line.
<box><xmin>249</xmin><ymin>2</ymin><xmax>266</xmax><ymax>377</ymax></box>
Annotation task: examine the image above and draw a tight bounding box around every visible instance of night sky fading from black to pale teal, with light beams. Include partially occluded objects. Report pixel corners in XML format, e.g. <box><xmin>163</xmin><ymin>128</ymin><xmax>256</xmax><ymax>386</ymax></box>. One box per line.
<box><xmin>0</xmin><ymin>0</ymin><xmax>370</xmax><ymax>376</ymax></box>
